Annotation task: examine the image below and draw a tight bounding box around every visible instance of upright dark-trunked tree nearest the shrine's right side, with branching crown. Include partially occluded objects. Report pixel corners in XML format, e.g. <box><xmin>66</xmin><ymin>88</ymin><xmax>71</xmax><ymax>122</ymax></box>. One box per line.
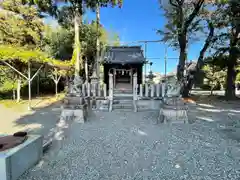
<box><xmin>159</xmin><ymin>0</ymin><xmax>204</xmax><ymax>81</ymax></box>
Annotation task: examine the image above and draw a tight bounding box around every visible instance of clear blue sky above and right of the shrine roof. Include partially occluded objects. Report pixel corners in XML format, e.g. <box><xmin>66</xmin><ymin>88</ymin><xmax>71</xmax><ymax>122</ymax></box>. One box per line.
<box><xmin>45</xmin><ymin>0</ymin><xmax>202</xmax><ymax>73</ymax></box>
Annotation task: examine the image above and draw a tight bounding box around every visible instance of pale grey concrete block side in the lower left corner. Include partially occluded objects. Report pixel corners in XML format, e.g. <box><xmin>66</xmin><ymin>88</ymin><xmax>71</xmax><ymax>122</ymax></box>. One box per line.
<box><xmin>0</xmin><ymin>135</ymin><xmax>43</xmax><ymax>180</ymax></box>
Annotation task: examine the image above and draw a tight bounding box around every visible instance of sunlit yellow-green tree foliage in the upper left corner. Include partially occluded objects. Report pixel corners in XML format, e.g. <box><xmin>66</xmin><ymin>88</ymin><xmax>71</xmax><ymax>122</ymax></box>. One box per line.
<box><xmin>0</xmin><ymin>0</ymin><xmax>44</xmax><ymax>49</ymax></box>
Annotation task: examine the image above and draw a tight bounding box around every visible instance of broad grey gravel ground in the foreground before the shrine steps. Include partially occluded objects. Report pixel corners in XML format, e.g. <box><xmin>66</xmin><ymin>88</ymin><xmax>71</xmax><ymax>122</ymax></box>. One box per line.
<box><xmin>19</xmin><ymin>109</ymin><xmax>240</xmax><ymax>180</ymax></box>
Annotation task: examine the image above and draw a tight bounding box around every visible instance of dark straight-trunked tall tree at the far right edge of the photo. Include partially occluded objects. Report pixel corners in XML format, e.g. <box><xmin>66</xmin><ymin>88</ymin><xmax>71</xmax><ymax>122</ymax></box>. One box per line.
<box><xmin>208</xmin><ymin>0</ymin><xmax>240</xmax><ymax>99</ymax></box>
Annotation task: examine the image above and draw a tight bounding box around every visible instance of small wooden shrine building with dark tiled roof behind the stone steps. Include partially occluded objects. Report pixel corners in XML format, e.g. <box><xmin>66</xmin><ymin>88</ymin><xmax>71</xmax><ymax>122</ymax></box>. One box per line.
<box><xmin>103</xmin><ymin>46</ymin><xmax>145</xmax><ymax>90</ymax></box>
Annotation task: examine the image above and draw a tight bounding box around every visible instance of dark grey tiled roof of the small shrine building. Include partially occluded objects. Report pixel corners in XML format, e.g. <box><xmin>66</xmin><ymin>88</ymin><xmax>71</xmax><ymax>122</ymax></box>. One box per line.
<box><xmin>103</xmin><ymin>46</ymin><xmax>145</xmax><ymax>64</ymax></box>
